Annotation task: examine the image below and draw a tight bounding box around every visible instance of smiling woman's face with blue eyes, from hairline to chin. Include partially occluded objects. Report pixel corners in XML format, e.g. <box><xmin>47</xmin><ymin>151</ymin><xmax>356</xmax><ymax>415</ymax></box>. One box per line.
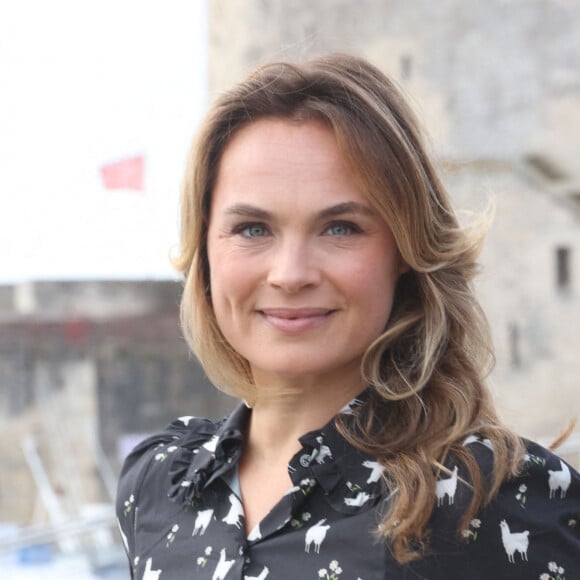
<box><xmin>208</xmin><ymin>119</ymin><xmax>401</xmax><ymax>387</ymax></box>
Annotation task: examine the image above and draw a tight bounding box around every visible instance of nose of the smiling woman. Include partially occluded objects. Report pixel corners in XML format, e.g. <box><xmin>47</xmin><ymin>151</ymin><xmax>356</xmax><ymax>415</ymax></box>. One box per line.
<box><xmin>268</xmin><ymin>239</ymin><xmax>321</xmax><ymax>294</ymax></box>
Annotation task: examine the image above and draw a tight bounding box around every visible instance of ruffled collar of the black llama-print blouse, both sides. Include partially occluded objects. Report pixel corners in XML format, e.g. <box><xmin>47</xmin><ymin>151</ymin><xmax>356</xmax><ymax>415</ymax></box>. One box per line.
<box><xmin>168</xmin><ymin>392</ymin><xmax>383</xmax><ymax>513</ymax></box>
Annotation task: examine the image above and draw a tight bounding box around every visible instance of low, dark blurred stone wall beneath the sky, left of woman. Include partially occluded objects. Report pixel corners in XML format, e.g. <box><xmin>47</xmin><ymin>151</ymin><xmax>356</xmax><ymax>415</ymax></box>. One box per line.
<box><xmin>0</xmin><ymin>281</ymin><xmax>234</xmax><ymax>524</ymax></box>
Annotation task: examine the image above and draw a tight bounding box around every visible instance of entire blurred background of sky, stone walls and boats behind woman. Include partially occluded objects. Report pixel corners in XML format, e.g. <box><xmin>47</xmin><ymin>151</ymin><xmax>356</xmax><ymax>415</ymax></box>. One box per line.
<box><xmin>0</xmin><ymin>0</ymin><xmax>580</xmax><ymax>580</ymax></box>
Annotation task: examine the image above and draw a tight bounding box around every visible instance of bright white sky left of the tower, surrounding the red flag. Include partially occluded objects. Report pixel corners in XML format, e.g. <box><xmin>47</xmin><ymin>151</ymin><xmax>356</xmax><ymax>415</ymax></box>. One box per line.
<box><xmin>0</xmin><ymin>0</ymin><xmax>207</xmax><ymax>284</ymax></box>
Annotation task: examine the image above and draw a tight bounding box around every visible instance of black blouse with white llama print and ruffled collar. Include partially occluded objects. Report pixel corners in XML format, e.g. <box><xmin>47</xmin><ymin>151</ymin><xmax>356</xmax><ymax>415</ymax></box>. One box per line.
<box><xmin>117</xmin><ymin>400</ymin><xmax>580</xmax><ymax>580</ymax></box>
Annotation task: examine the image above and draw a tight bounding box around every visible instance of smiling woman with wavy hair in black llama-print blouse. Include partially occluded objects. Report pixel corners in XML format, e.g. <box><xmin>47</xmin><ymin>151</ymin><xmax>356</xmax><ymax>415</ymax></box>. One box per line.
<box><xmin>118</xmin><ymin>55</ymin><xmax>580</xmax><ymax>580</ymax></box>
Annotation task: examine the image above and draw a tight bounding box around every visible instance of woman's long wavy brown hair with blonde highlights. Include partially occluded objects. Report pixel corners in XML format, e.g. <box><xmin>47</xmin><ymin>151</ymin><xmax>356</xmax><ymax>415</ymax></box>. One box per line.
<box><xmin>174</xmin><ymin>54</ymin><xmax>523</xmax><ymax>562</ymax></box>
